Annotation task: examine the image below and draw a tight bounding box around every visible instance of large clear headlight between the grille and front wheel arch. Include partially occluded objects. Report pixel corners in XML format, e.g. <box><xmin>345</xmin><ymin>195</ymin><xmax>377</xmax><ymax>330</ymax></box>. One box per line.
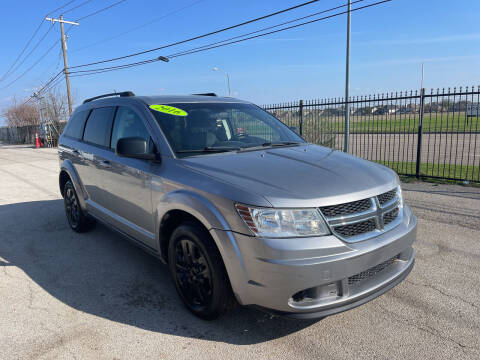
<box><xmin>235</xmin><ymin>204</ymin><xmax>330</xmax><ymax>237</ymax></box>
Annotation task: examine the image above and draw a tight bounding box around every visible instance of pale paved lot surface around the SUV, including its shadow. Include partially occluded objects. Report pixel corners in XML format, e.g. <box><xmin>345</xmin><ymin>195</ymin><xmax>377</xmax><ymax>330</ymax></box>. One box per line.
<box><xmin>0</xmin><ymin>145</ymin><xmax>480</xmax><ymax>360</ymax></box>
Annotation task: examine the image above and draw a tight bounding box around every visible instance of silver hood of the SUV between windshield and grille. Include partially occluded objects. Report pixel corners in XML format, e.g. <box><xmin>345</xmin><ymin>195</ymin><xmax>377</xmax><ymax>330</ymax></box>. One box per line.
<box><xmin>180</xmin><ymin>145</ymin><xmax>398</xmax><ymax>207</ymax></box>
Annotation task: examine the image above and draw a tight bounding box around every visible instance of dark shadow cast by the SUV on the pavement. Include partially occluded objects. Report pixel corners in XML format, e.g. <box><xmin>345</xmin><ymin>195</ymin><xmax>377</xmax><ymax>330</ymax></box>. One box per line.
<box><xmin>0</xmin><ymin>200</ymin><xmax>316</xmax><ymax>345</ymax></box>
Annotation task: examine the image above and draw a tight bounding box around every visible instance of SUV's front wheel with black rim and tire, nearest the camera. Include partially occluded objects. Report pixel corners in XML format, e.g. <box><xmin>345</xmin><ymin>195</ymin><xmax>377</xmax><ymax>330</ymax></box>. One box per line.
<box><xmin>168</xmin><ymin>222</ymin><xmax>236</xmax><ymax>320</ymax></box>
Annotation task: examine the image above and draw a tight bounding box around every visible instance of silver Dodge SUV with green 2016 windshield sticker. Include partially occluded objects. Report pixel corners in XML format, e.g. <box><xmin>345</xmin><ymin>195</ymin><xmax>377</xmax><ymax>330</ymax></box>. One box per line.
<box><xmin>58</xmin><ymin>92</ymin><xmax>417</xmax><ymax>319</ymax></box>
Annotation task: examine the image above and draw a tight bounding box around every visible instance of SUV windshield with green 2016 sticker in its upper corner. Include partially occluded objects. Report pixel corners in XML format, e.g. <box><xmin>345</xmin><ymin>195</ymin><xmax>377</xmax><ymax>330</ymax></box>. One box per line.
<box><xmin>150</xmin><ymin>102</ymin><xmax>305</xmax><ymax>156</ymax></box>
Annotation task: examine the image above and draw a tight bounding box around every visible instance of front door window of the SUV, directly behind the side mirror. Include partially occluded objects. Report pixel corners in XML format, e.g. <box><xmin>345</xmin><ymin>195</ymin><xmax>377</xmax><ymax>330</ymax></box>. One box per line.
<box><xmin>110</xmin><ymin>106</ymin><xmax>150</xmax><ymax>150</ymax></box>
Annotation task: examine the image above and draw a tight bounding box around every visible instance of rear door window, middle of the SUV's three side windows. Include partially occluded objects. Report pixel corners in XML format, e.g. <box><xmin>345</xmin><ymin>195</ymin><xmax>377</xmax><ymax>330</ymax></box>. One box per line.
<box><xmin>83</xmin><ymin>107</ymin><xmax>115</xmax><ymax>147</ymax></box>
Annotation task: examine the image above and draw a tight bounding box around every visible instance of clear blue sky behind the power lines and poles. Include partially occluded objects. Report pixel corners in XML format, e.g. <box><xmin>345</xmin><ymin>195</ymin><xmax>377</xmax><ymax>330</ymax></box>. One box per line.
<box><xmin>0</xmin><ymin>0</ymin><xmax>480</xmax><ymax>121</ymax></box>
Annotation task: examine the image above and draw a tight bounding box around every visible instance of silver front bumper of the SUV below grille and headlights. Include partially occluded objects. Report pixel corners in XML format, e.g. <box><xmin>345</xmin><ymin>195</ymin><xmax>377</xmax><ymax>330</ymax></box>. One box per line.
<box><xmin>211</xmin><ymin>206</ymin><xmax>417</xmax><ymax>318</ymax></box>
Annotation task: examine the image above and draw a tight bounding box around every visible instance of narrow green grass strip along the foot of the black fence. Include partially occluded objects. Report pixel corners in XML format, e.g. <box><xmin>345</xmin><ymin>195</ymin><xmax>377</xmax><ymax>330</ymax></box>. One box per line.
<box><xmin>377</xmin><ymin>161</ymin><xmax>480</xmax><ymax>181</ymax></box>
